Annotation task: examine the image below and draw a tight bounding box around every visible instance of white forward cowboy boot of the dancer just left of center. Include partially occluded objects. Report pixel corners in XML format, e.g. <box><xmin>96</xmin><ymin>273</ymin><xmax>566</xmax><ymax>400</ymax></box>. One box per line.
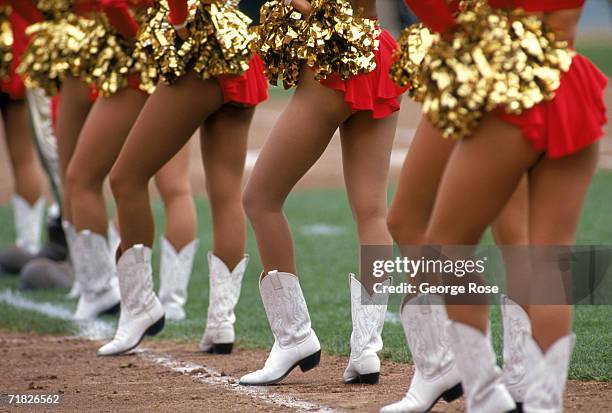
<box><xmin>98</xmin><ymin>244</ymin><xmax>165</xmax><ymax>356</ymax></box>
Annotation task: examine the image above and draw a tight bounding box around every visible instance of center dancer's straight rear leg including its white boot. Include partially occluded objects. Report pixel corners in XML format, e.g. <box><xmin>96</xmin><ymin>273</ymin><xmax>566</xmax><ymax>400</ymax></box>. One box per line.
<box><xmin>340</xmin><ymin>108</ymin><xmax>398</xmax><ymax>384</ymax></box>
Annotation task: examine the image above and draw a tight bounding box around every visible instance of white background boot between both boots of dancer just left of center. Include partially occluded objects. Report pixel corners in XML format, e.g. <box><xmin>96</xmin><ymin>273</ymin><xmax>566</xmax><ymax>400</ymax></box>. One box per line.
<box><xmin>159</xmin><ymin>237</ymin><xmax>200</xmax><ymax>320</ymax></box>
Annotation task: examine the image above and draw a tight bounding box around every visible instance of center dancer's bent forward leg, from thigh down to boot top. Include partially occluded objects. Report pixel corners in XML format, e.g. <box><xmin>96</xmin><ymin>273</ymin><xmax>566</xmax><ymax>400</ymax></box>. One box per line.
<box><xmin>243</xmin><ymin>69</ymin><xmax>350</xmax><ymax>274</ymax></box>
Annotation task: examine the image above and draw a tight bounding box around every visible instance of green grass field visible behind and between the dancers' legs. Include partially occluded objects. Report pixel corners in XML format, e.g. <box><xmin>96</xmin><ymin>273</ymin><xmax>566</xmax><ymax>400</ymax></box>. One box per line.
<box><xmin>0</xmin><ymin>172</ymin><xmax>612</xmax><ymax>381</ymax></box>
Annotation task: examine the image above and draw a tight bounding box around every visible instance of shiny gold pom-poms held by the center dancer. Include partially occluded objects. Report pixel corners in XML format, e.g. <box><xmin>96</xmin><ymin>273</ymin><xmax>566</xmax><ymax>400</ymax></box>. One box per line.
<box><xmin>255</xmin><ymin>0</ymin><xmax>380</xmax><ymax>89</ymax></box>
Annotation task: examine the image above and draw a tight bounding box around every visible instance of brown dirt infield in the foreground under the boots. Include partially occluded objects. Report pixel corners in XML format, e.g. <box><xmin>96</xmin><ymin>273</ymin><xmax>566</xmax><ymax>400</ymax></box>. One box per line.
<box><xmin>0</xmin><ymin>332</ymin><xmax>612</xmax><ymax>413</ymax></box>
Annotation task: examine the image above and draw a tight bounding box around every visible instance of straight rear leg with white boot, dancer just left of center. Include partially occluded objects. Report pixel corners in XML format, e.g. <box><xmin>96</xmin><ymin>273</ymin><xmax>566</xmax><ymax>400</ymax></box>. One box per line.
<box><xmin>199</xmin><ymin>105</ymin><xmax>255</xmax><ymax>354</ymax></box>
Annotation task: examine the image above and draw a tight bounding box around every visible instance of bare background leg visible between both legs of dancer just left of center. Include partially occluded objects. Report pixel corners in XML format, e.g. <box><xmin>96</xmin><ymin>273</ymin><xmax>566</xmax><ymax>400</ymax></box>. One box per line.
<box><xmin>155</xmin><ymin>145</ymin><xmax>197</xmax><ymax>251</ymax></box>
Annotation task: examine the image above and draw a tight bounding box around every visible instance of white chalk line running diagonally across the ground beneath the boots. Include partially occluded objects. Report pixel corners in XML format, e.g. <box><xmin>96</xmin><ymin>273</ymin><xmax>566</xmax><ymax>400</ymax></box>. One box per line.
<box><xmin>0</xmin><ymin>289</ymin><xmax>339</xmax><ymax>413</ymax></box>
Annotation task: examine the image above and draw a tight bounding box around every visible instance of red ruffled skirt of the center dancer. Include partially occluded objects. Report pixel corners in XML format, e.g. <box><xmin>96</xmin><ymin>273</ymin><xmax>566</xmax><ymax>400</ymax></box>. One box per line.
<box><xmin>320</xmin><ymin>30</ymin><xmax>406</xmax><ymax>119</ymax></box>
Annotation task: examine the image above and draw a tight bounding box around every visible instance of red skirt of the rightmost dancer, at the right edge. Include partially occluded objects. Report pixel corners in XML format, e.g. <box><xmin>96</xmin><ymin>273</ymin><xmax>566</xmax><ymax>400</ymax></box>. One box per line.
<box><xmin>497</xmin><ymin>54</ymin><xmax>608</xmax><ymax>158</ymax></box>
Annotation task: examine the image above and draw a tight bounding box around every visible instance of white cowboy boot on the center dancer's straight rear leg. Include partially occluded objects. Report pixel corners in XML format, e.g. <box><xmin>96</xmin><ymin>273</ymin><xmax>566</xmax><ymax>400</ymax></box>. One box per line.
<box><xmin>343</xmin><ymin>274</ymin><xmax>393</xmax><ymax>384</ymax></box>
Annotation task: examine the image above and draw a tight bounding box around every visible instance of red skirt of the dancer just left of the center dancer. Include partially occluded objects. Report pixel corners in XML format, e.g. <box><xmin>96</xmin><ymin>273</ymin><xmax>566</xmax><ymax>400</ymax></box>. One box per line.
<box><xmin>217</xmin><ymin>55</ymin><xmax>268</xmax><ymax>106</ymax></box>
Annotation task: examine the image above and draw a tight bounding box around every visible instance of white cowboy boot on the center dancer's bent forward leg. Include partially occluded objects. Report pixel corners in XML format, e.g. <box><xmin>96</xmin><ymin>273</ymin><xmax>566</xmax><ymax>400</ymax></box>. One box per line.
<box><xmin>240</xmin><ymin>271</ymin><xmax>321</xmax><ymax>386</ymax></box>
